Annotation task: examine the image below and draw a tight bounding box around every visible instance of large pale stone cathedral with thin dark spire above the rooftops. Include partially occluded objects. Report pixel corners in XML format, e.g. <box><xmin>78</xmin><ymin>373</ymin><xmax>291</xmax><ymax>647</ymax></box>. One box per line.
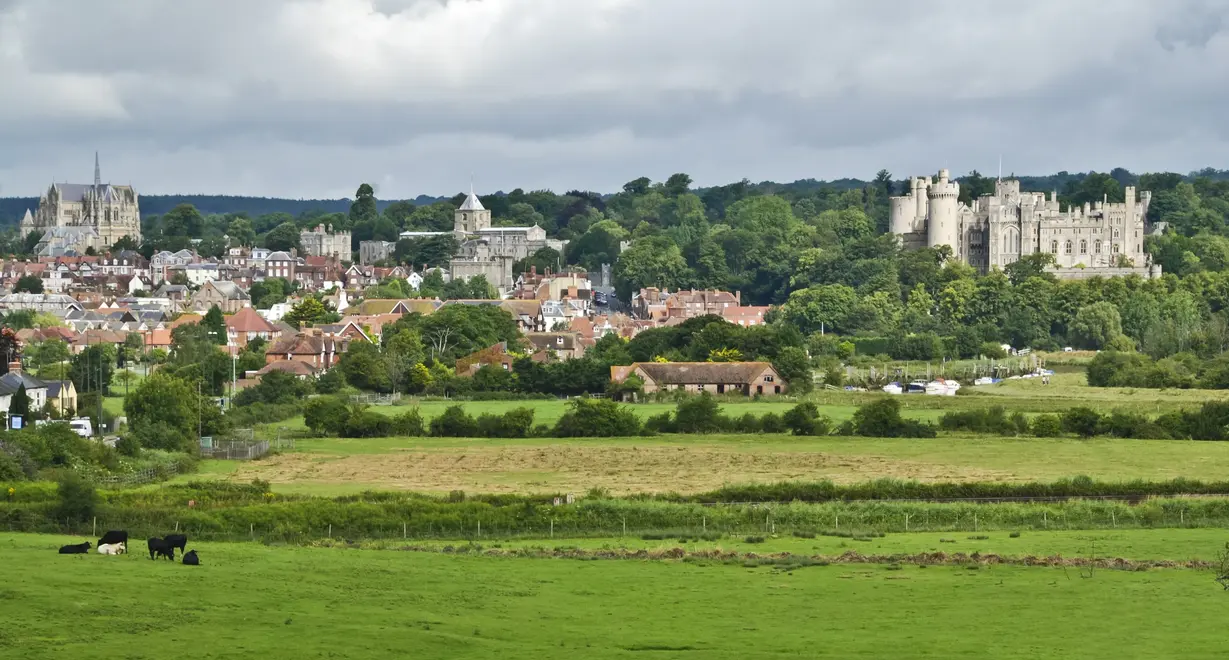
<box><xmin>21</xmin><ymin>154</ymin><xmax>141</xmax><ymax>257</ymax></box>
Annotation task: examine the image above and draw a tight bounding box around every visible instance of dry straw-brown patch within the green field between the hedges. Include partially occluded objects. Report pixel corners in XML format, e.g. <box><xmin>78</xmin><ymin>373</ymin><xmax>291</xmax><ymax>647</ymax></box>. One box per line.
<box><xmin>231</xmin><ymin>445</ymin><xmax>1015</xmax><ymax>494</ymax></box>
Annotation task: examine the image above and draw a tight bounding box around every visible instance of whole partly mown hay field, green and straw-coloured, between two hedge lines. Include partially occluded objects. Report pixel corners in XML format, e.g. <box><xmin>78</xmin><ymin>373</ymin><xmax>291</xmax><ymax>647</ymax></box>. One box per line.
<box><xmin>199</xmin><ymin>435</ymin><xmax>1229</xmax><ymax>494</ymax></box>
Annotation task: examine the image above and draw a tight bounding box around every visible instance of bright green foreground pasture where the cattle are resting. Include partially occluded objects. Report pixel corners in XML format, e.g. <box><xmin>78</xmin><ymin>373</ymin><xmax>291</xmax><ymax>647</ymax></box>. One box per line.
<box><xmin>0</xmin><ymin>535</ymin><xmax>1229</xmax><ymax>660</ymax></box>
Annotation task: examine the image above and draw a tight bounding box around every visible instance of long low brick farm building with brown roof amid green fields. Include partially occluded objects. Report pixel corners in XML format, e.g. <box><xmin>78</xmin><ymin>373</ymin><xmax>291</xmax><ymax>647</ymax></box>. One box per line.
<box><xmin>611</xmin><ymin>363</ymin><xmax>789</xmax><ymax>396</ymax></box>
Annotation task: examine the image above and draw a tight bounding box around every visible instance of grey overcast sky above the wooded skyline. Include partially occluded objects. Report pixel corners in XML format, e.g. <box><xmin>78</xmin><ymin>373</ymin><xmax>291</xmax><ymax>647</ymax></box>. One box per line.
<box><xmin>0</xmin><ymin>0</ymin><xmax>1229</xmax><ymax>199</ymax></box>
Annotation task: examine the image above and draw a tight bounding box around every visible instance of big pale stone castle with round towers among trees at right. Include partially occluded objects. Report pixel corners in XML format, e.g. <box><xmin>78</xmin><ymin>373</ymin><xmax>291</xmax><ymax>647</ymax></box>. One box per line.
<box><xmin>889</xmin><ymin>170</ymin><xmax>1161</xmax><ymax>279</ymax></box>
